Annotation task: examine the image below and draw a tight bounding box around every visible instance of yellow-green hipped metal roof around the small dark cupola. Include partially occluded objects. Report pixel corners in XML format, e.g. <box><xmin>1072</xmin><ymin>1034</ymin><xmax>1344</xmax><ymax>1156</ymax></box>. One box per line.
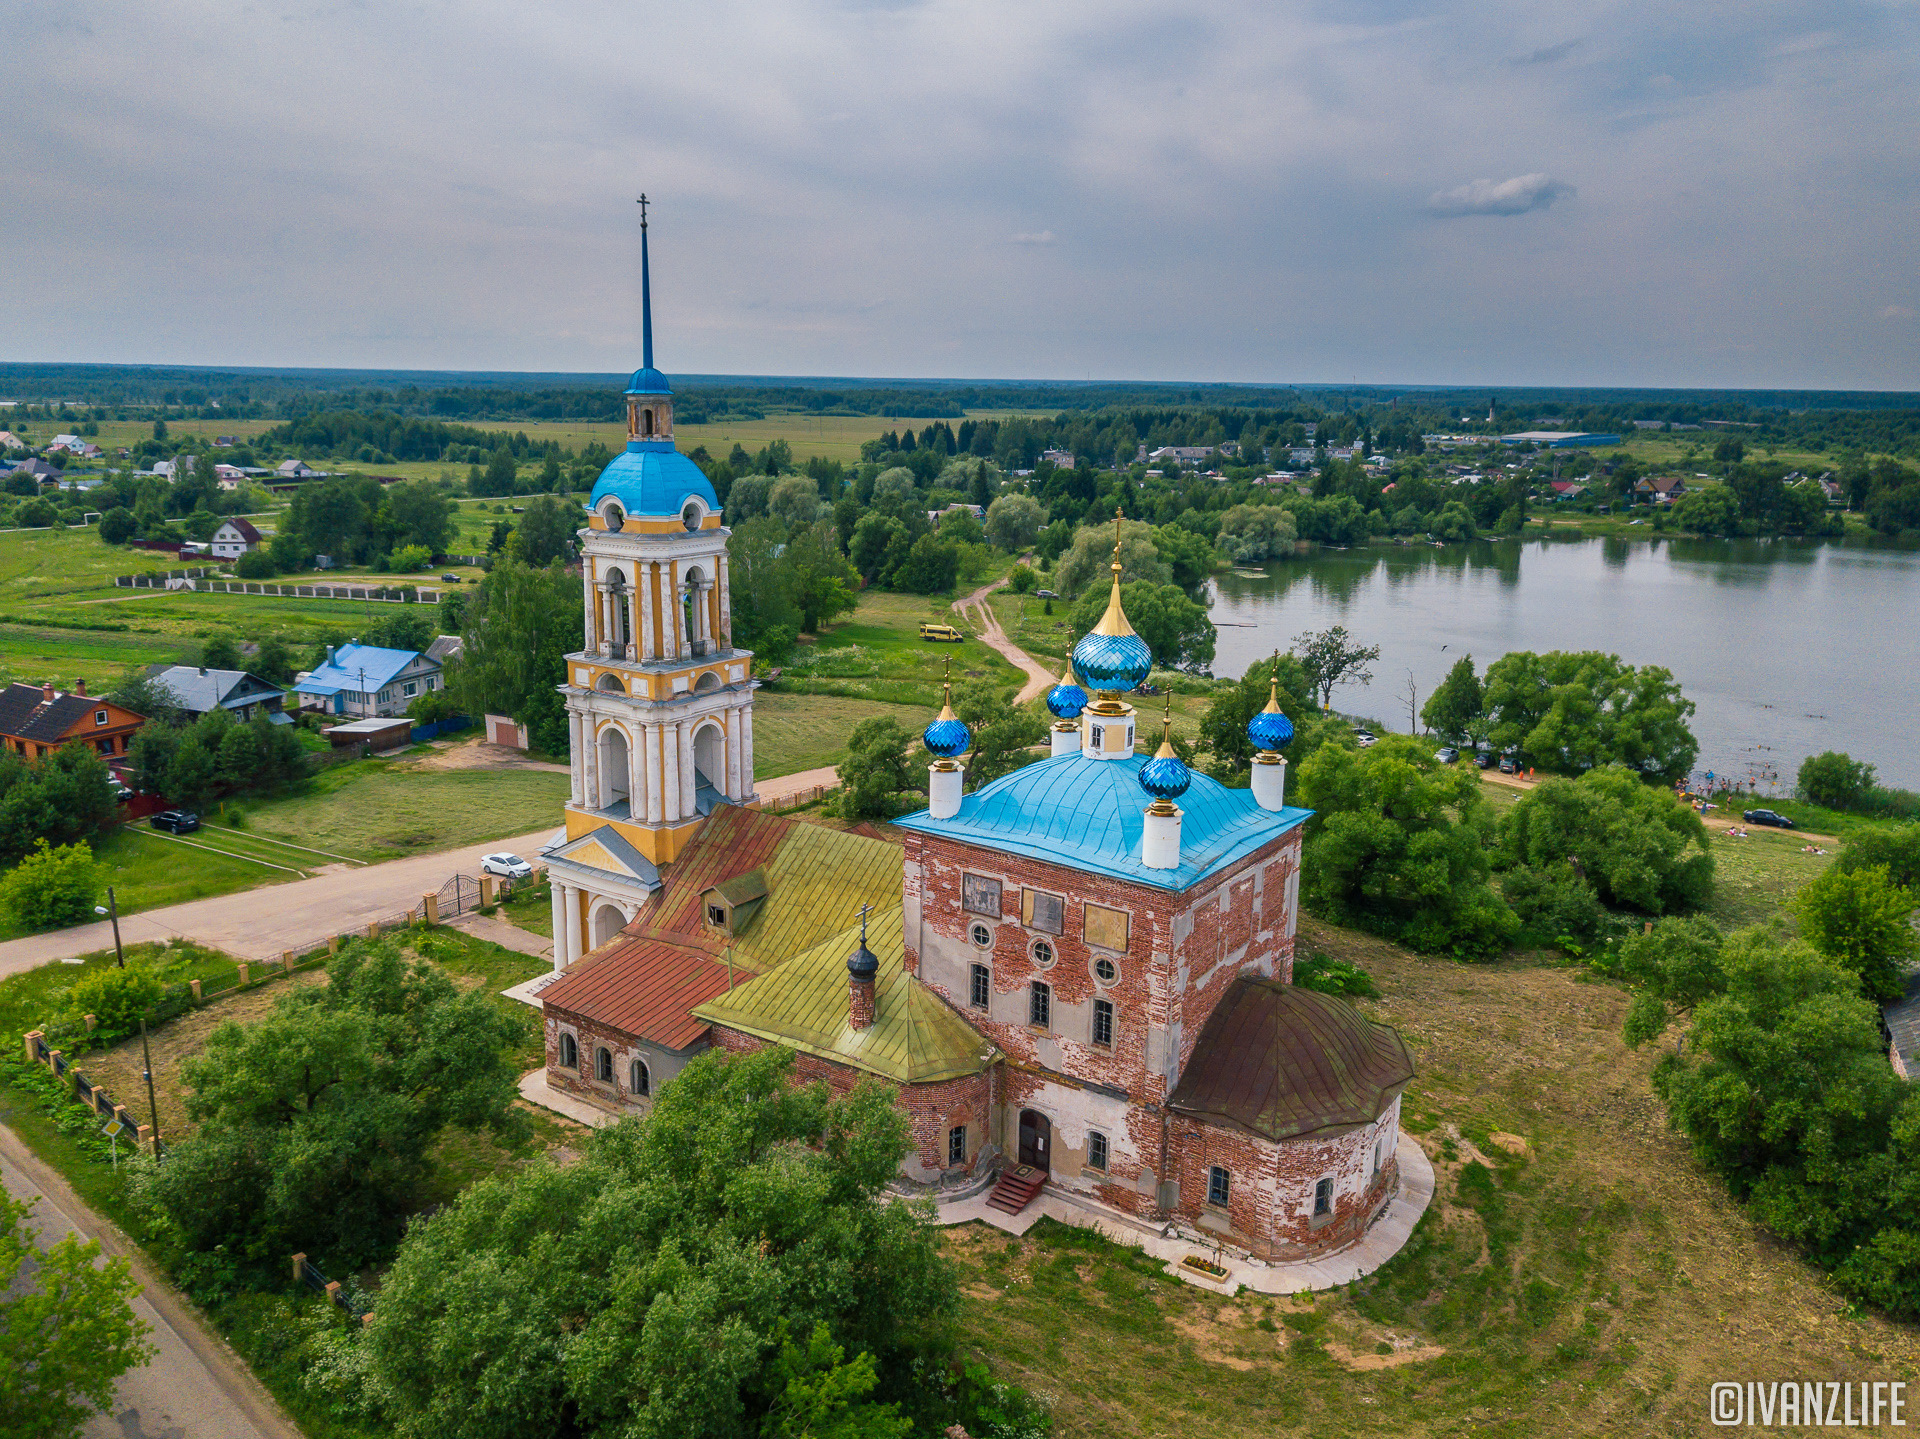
<box><xmin>693</xmin><ymin>910</ymin><xmax>998</xmax><ymax>1084</ymax></box>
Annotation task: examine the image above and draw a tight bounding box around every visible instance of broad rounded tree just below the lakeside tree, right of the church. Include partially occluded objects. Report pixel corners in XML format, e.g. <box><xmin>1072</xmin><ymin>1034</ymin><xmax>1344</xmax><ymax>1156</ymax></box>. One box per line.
<box><xmin>1494</xmin><ymin>765</ymin><xmax>1713</xmax><ymax>915</ymax></box>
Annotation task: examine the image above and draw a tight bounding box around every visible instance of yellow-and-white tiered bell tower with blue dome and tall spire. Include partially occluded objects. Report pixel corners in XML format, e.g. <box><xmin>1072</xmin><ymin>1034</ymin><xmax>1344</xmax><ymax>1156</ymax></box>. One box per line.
<box><xmin>547</xmin><ymin>198</ymin><xmax>755</xmax><ymax>968</ymax></box>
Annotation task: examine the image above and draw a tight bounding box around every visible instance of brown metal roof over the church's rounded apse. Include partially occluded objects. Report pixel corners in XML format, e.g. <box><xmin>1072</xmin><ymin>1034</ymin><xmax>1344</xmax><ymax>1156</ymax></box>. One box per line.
<box><xmin>1167</xmin><ymin>978</ymin><xmax>1413</xmax><ymax>1139</ymax></box>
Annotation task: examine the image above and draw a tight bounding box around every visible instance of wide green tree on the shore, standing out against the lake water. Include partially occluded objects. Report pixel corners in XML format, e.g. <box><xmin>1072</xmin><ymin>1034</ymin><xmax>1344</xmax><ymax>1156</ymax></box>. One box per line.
<box><xmin>1484</xmin><ymin>649</ymin><xmax>1699</xmax><ymax>784</ymax></box>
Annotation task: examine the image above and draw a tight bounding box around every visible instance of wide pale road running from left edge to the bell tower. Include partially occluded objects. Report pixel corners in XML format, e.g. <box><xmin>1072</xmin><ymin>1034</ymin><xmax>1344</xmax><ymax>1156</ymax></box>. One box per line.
<box><xmin>0</xmin><ymin>817</ymin><xmax>559</xmax><ymax>976</ymax></box>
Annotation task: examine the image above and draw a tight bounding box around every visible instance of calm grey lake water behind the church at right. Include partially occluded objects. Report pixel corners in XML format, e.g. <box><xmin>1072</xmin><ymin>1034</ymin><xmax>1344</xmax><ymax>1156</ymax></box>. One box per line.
<box><xmin>1212</xmin><ymin>540</ymin><xmax>1920</xmax><ymax>793</ymax></box>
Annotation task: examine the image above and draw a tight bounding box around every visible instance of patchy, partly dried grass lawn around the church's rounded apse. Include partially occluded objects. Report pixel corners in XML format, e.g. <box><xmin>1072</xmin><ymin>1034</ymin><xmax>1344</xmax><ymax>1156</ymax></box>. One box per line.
<box><xmin>947</xmin><ymin>920</ymin><xmax>1920</xmax><ymax>1439</ymax></box>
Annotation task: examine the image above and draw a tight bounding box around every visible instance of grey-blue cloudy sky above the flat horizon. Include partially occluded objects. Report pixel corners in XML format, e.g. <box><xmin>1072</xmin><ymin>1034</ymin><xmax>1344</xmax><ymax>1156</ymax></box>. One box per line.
<box><xmin>0</xmin><ymin>0</ymin><xmax>1920</xmax><ymax>388</ymax></box>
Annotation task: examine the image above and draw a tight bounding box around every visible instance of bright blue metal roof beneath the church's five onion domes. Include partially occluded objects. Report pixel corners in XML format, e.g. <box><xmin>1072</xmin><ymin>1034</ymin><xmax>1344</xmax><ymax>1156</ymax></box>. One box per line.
<box><xmin>895</xmin><ymin>753</ymin><xmax>1313</xmax><ymax>890</ymax></box>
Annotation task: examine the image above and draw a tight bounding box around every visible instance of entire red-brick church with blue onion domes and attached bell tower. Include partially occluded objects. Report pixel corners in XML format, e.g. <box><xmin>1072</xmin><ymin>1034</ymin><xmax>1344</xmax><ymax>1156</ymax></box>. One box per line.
<box><xmin>541</xmin><ymin>213</ymin><xmax>1413</xmax><ymax>1260</ymax></box>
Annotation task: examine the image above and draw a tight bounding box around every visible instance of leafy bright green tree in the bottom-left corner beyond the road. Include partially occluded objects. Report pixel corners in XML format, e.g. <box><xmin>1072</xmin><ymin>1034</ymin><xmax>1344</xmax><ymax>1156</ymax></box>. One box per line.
<box><xmin>0</xmin><ymin>1193</ymin><xmax>156</xmax><ymax>1439</ymax></box>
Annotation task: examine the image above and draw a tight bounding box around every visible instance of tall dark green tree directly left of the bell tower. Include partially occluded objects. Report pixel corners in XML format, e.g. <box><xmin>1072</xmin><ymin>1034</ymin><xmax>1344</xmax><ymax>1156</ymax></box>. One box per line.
<box><xmin>449</xmin><ymin>555</ymin><xmax>586</xmax><ymax>755</ymax></box>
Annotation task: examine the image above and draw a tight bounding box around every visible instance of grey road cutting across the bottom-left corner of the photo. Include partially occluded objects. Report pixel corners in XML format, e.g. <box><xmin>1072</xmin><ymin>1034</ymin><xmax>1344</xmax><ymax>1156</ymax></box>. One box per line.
<box><xmin>0</xmin><ymin>1126</ymin><xmax>300</xmax><ymax>1439</ymax></box>
